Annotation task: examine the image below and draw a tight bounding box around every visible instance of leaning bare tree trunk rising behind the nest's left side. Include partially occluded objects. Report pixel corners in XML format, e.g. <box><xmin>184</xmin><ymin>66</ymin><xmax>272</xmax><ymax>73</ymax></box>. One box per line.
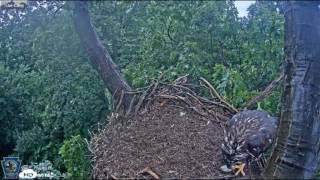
<box><xmin>73</xmin><ymin>1</ymin><xmax>131</xmax><ymax>105</ymax></box>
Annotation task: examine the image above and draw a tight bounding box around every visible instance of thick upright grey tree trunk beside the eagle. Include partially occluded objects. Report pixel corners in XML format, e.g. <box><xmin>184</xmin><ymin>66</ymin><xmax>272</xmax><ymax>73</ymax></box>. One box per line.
<box><xmin>263</xmin><ymin>1</ymin><xmax>320</xmax><ymax>179</ymax></box>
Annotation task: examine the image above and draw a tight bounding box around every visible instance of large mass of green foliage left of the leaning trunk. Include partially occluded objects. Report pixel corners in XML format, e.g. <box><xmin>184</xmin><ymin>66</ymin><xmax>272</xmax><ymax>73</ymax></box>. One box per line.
<box><xmin>0</xmin><ymin>2</ymin><xmax>108</xmax><ymax>171</ymax></box>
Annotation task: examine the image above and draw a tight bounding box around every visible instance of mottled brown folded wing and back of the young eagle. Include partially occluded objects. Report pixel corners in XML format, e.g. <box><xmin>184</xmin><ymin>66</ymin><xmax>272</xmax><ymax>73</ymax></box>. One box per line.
<box><xmin>222</xmin><ymin>110</ymin><xmax>277</xmax><ymax>155</ymax></box>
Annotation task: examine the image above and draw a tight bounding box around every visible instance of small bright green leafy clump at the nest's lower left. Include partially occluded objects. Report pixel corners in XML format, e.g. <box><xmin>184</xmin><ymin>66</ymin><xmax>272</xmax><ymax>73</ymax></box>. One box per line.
<box><xmin>59</xmin><ymin>135</ymin><xmax>90</xmax><ymax>179</ymax></box>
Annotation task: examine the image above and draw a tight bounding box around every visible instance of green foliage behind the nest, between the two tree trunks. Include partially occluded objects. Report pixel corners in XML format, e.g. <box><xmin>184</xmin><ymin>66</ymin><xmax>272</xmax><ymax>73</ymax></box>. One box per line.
<box><xmin>92</xmin><ymin>1</ymin><xmax>283</xmax><ymax>114</ymax></box>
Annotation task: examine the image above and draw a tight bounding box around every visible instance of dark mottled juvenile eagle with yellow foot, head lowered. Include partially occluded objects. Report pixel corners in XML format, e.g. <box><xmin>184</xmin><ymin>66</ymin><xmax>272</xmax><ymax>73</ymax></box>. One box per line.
<box><xmin>221</xmin><ymin>110</ymin><xmax>278</xmax><ymax>176</ymax></box>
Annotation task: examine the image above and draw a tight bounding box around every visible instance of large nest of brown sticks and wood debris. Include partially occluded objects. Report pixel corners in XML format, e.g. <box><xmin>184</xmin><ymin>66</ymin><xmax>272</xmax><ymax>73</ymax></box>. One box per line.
<box><xmin>89</xmin><ymin>76</ymin><xmax>236</xmax><ymax>179</ymax></box>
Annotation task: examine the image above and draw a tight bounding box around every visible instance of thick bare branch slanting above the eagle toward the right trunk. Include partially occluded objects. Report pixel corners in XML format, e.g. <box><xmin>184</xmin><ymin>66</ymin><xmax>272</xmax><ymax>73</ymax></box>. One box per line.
<box><xmin>244</xmin><ymin>73</ymin><xmax>284</xmax><ymax>109</ymax></box>
